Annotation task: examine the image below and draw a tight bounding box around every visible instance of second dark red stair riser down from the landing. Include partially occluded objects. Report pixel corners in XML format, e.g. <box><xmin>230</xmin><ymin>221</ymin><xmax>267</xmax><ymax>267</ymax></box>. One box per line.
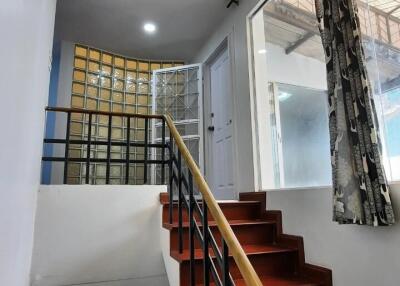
<box><xmin>170</xmin><ymin>224</ymin><xmax>275</xmax><ymax>250</ymax></box>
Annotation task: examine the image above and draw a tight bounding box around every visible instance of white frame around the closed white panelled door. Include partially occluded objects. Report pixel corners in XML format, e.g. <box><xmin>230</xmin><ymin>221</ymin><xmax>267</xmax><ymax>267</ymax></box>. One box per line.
<box><xmin>203</xmin><ymin>29</ymin><xmax>239</xmax><ymax>199</ymax></box>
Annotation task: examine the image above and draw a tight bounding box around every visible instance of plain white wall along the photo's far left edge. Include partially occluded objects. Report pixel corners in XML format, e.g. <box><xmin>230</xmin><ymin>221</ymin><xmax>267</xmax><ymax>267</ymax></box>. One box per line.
<box><xmin>0</xmin><ymin>0</ymin><xmax>56</xmax><ymax>286</ymax></box>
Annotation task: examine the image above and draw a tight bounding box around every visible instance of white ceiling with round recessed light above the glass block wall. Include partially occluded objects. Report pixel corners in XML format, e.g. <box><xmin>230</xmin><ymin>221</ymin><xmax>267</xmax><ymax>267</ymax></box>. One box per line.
<box><xmin>55</xmin><ymin>0</ymin><xmax>235</xmax><ymax>61</ymax></box>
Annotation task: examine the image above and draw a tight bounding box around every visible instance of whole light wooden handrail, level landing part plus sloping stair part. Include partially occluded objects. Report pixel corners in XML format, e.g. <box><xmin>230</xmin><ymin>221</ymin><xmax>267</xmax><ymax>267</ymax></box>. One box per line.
<box><xmin>46</xmin><ymin>107</ymin><xmax>262</xmax><ymax>286</ymax></box>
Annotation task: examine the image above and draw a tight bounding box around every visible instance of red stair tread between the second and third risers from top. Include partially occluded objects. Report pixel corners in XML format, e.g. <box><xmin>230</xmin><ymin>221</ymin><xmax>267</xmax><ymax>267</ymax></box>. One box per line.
<box><xmin>171</xmin><ymin>244</ymin><xmax>297</xmax><ymax>262</ymax></box>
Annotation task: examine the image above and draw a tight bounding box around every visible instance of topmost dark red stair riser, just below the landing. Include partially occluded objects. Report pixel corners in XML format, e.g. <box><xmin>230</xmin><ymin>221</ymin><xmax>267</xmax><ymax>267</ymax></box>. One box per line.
<box><xmin>163</xmin><ymin>203</ymin><xmax>260</xmax><ymax>223</ymax></box>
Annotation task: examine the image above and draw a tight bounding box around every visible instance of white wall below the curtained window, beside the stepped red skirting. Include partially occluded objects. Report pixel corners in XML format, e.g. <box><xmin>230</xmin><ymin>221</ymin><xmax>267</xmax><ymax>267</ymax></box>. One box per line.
<box><xmin>267</xmin><ymin>184</ymin><xmax>400</xmax><ymax>286</ymax></box>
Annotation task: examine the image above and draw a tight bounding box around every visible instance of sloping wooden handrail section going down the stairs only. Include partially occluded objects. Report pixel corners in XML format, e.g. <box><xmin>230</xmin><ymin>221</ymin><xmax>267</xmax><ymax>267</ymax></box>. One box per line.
<box><xmin>164</xmin><ymin>115</ymin><xmax>262</xmax><ymax>286</ymax></box>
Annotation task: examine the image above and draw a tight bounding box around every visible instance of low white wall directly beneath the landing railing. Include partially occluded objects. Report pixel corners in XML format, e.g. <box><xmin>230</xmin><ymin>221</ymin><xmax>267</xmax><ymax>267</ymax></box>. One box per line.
<box><xmin>31</xmin><ymin>185</ymin><xmax>168</xmax><ymax>286</ymax></box>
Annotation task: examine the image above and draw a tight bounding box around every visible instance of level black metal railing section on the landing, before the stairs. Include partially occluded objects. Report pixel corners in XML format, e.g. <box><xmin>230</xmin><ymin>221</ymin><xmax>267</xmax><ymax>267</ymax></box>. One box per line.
<box><xmin>42</xmin><ymin>107</ymin><xmax>168</xmax><ymax>184</ymax></box>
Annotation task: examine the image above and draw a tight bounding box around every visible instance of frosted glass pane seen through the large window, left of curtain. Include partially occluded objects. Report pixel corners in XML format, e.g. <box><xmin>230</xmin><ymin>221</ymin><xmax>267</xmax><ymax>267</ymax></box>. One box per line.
<box><xmin>272</xmin><ymin>84</ymin><xmax>331</xmax><ymax>188</ymax></box>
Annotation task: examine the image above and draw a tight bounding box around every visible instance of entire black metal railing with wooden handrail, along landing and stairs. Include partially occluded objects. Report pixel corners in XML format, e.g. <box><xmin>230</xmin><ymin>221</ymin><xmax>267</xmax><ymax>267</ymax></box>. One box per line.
<box><xmin>43</xmin><ymin>107</ymin><xmax>261</xmax><ymax>286</ymax></box>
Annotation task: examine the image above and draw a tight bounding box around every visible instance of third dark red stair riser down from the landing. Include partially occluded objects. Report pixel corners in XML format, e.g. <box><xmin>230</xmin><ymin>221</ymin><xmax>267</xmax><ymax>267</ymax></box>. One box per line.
<box><xmin>180</xmin><ymin>252</ymin><xmax>297</xmax><ymax>286</ymax></box>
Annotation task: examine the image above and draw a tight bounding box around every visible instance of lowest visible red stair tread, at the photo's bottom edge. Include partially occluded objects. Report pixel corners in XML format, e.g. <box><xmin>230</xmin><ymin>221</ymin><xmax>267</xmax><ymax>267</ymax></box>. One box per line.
<box><xmin>198</xmin><ymin>276</ymin><xmax>320</xmax><ymax>286</ymax></box>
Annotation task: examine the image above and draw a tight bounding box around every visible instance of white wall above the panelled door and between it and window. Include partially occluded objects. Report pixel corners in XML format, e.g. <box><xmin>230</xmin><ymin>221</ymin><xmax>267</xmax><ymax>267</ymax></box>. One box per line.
<box><xmin>191</xmin><ymin>0</ymin><xmax>258</xmax><ymax>192</ymax></box>
